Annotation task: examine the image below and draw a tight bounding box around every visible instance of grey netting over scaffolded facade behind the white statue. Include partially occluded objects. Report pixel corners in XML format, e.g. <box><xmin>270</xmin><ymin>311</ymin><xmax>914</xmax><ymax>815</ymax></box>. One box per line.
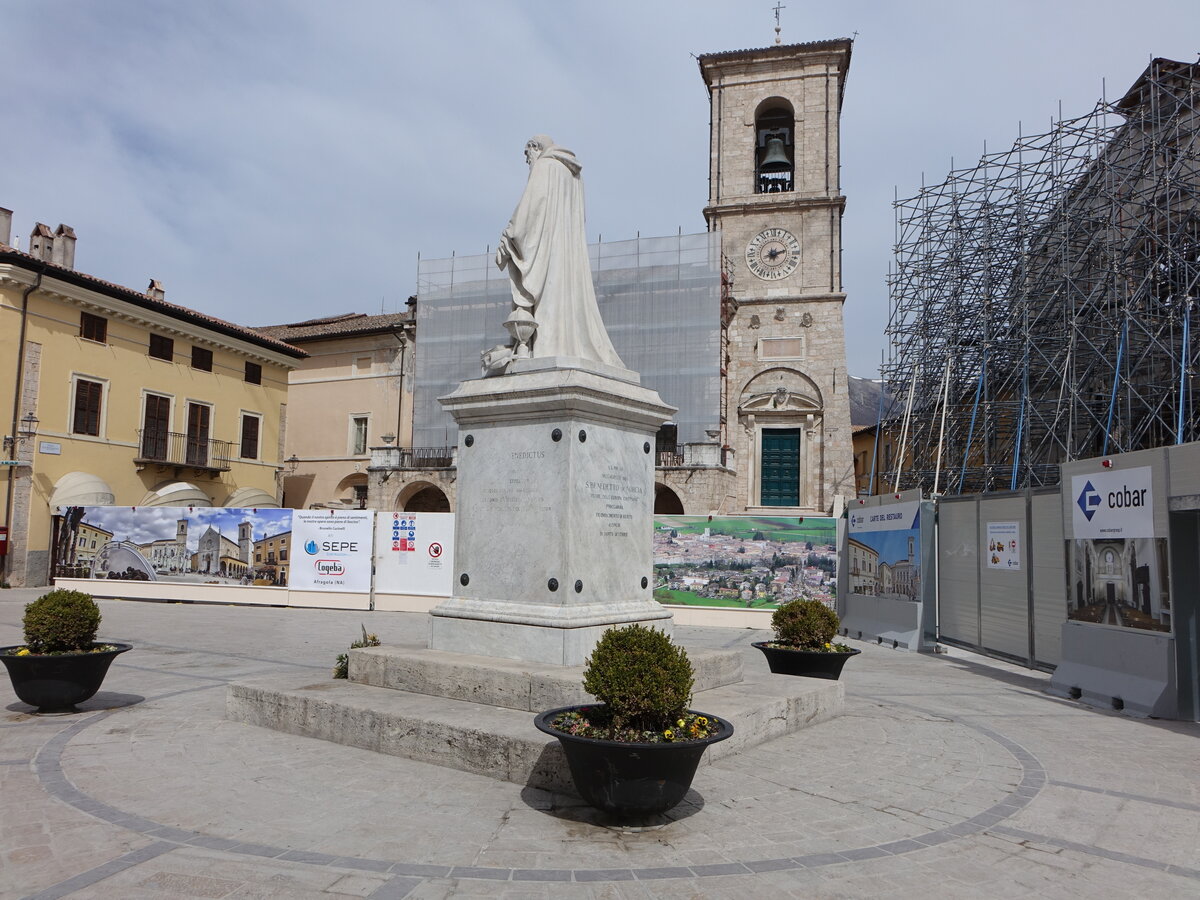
<box><xmin>413</xmin><ymin>232</ymin><xmax>721</xmax><ymax>446</ymax></box>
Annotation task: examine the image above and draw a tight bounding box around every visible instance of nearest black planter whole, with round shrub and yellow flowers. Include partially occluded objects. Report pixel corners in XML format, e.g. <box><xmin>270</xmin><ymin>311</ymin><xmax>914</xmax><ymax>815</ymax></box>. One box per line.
<box><xmin>535</xmin><ymin>625</ymin><xmax>733</xmax><ymax>822</ymax></box>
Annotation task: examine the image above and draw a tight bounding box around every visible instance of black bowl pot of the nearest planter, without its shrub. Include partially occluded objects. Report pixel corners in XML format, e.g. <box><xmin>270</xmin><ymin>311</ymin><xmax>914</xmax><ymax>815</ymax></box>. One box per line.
<box><xmin>534</xmin><ymin>704</ymin><xmax>733</xmax><ymax>821</ymax></box>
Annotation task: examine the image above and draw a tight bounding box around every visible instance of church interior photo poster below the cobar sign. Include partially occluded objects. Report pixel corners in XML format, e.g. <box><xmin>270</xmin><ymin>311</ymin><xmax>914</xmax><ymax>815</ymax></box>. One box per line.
<box><xmin>1067</xmin><ymin>538</ymin><xmax>1171</xmax><ymax>631</ymax></box>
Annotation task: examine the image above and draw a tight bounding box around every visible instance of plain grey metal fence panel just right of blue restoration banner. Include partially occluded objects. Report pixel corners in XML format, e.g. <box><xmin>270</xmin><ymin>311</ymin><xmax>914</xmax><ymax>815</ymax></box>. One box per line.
<box><xmin>937</xmin><ymin>497</ymin><xmax>979</xmax><ymax>647</ymax></box>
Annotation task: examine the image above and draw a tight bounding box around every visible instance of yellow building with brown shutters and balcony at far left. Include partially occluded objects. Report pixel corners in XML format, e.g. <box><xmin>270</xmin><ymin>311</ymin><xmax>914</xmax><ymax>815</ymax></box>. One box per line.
<box><xmin>0</xmin><ymin>210</ymin><xmax>306</xmax><ymax>586</ymax></box>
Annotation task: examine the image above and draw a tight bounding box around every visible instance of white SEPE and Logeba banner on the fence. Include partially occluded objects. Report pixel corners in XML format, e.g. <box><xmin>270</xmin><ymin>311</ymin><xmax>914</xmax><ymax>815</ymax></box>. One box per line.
<box><xmin>292</xmin><ymin>509</ymin><xmax>374</xmax><ymax>594</ymax></box>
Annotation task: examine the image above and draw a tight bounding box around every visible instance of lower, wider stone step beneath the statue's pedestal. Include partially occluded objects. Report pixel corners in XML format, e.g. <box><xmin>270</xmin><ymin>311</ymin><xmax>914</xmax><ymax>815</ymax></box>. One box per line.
<box><xmin>226</xmin><ymin>674</ymin><xmax>845</xmax><ymax>793</ymax></box>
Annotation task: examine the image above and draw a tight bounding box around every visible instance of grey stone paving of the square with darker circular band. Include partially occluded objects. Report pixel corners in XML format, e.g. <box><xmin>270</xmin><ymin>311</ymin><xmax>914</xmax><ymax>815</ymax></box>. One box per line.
<box><xmin>0</xmin><ymin>589</ymin><xmax>1200</xmax><ymax>900</ymax></box>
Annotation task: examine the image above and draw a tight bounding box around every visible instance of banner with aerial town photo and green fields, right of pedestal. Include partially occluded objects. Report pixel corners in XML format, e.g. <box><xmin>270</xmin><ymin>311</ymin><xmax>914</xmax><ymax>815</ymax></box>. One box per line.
<box><xmin>654</xmin><ymin>516</ymin><xmax>838</xmax><ymax>610</ymax></box>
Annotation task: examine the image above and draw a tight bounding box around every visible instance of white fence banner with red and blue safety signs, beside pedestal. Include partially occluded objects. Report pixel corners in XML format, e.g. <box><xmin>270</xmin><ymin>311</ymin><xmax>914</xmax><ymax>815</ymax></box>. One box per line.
<box><xmin>376</xmin><ymin>512</ymin><xmax>454</xmax><ymax>596</ymax></box>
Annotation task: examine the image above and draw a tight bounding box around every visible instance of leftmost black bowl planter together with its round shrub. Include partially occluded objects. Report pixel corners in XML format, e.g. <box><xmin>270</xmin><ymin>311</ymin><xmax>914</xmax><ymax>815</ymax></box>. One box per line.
<box><xmin>0</xmin><ymin>589</ymin><xmax>132</xmax><ymax>713</ymax></box>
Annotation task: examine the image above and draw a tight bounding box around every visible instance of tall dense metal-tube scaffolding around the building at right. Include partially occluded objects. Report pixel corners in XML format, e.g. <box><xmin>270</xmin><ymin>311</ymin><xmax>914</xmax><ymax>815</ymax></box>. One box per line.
<box><xmin>881</xmin><ymin>59</ymin><xmax>1200</xmax><ymax>493</ymax></box>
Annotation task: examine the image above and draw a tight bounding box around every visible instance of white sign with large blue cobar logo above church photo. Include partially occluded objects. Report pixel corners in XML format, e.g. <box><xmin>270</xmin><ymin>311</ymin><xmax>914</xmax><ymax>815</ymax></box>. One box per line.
<box><xmin>1070</xmin><ymin>466</ymin><xmax>1154</xmax><ymax>538</ymax></box>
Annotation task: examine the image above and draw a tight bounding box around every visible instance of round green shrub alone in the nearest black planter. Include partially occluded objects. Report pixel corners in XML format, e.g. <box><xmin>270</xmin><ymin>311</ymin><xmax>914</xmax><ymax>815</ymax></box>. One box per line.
<box><xmin>583</xmin><ymin>625</ymin><xmax>695</xmax><ymax>731</ymax></box>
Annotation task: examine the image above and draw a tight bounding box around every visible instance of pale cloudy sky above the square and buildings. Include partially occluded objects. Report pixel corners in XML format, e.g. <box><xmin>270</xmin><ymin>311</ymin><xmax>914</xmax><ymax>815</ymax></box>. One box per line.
<box><xmin>0</xmin><ymin>0</ymin><xmax>1200</xmax><ymax>377</ymax></box>
